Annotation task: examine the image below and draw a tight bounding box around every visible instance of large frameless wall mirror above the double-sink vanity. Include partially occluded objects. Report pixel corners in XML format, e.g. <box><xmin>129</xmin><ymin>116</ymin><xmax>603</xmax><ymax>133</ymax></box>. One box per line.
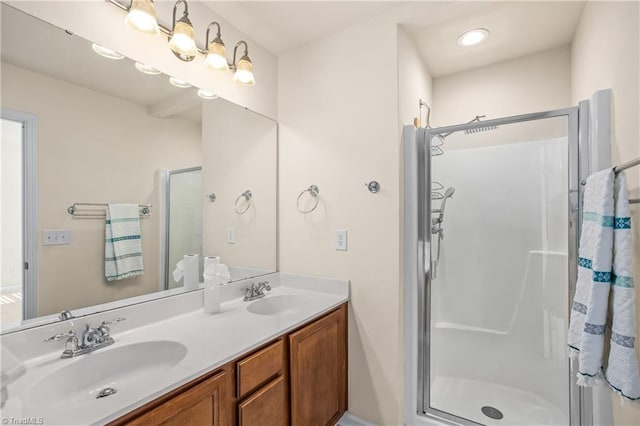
<box><xmin>0</xmin><ymin>4</ymin><xmax>277</xmax><ymax>331</ymax></box>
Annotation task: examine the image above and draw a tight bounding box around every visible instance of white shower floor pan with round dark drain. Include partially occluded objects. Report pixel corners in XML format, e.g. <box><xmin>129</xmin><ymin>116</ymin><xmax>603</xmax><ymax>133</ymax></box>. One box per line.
<box><xmin>430</xmin><ymin>377</ymin><xmax>569</xmax><ymax>426</ymax></box>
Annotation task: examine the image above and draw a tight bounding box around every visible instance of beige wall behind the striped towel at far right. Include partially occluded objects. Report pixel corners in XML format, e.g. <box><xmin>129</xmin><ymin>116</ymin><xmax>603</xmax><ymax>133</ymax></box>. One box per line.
<box><xmin>571</xmin><ymin>2</ymin><xmax>640</xmax><ymax>425</ymax></box>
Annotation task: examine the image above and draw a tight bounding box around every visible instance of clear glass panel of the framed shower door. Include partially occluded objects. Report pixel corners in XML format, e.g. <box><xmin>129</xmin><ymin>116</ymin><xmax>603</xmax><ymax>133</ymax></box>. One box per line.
<box><xmin>423</xmin><ymin>109</ymin><xmax>577</xmax><ymax>426</ymax></box>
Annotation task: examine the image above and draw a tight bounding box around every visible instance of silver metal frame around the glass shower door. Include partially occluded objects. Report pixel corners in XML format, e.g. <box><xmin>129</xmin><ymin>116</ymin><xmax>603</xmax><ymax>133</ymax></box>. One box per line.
<box><xmin>412</xmin><ymin>102</ymin><xmax>593</xmax><ymax>426</ymax></box>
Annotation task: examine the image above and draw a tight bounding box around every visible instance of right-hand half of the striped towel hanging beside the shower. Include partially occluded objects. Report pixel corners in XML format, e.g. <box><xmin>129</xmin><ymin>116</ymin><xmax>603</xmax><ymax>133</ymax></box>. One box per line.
<box><xmin>605</xmin><ymin>172</ymin><xmax>640</xmax><ymax>399</ymax></box>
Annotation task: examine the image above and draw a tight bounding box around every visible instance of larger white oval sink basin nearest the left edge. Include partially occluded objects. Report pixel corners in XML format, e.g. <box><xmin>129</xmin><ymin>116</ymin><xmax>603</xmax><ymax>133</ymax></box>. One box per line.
<box><xmin>25</xmin><ymin>341</ymin><xmax>187</xmax><ymax>405</ymax></box>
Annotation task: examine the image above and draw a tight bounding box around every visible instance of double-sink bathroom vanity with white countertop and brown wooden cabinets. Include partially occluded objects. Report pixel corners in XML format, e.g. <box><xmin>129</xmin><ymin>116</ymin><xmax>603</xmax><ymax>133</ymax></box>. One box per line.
<box><xmin>0</xmin><ymin>273</ymin><xmax>349</xmax><ymax>425</ymax></box>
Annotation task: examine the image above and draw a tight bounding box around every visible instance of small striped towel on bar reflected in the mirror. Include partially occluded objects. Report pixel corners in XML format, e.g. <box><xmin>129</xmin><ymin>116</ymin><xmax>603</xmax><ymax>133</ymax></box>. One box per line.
<box><xmin>104</xmin><ymin>204</ymin><xmax>144</xmax><ymax>281</ymax></box>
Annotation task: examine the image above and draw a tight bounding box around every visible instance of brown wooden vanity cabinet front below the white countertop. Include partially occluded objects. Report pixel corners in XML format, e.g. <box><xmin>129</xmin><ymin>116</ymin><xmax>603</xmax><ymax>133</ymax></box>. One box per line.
<box><xmin>109</xmin><ymin>304</ymin><xmax>347</xmax><ymax>426</ymax></box>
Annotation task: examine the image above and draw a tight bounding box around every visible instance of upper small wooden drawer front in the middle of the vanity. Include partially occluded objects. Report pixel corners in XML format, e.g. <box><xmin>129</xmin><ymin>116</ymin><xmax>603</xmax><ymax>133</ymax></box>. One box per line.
<box><xmin>237</xmin><ymin>339</ymin><xmax>284</xmax><ymax>399</ymax></box>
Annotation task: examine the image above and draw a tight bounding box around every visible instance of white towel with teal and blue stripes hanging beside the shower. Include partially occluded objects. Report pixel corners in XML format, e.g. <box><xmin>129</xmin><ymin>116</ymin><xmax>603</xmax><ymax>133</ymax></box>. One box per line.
<box><xmin>568</xmin><ymin>169</ymin><xmax>640</xmax><ymax>399</ymax></box>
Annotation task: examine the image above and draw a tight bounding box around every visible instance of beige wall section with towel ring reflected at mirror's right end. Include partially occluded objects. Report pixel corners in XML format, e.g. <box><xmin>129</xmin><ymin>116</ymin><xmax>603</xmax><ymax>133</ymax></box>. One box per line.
<box><xmin>202</xmin><ymin>99</ymin><xmax>277</xmax><ymax>270</ymax></box>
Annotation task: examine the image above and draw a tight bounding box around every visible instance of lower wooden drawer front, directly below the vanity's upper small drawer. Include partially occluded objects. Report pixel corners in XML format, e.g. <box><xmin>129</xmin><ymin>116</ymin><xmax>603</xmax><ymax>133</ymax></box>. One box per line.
<box><xmin>238</xmin><ymin>376</ymin><xmax>289</xmax><ymax>426</ymax></box>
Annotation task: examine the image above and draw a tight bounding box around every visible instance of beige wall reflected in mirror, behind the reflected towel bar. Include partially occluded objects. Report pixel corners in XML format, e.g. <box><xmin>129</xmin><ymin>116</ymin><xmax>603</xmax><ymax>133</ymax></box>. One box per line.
<box><xmin>2</xmin><ymin>63</ymin><xmax>201</xmax><ymax>315</ymax></box>
